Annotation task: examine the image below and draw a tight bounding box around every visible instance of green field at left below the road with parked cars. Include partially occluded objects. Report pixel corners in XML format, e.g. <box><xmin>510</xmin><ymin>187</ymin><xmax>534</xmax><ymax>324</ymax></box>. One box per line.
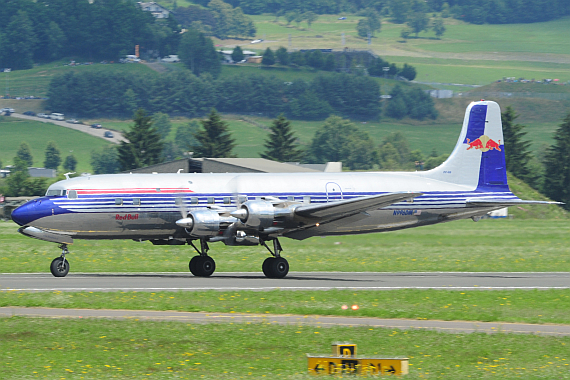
<box><xmin>0</xmin><ymin>119</ymin><xmax>110</xmax><ymax>173</ymax></box>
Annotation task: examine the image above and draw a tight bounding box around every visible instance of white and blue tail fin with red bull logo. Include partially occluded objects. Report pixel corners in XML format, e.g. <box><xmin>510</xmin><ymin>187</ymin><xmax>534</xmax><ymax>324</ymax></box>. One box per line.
<box><xmin>425</xmin><ymin>101</ymin><xmax>509</xmax><ymax>192</ymax></box>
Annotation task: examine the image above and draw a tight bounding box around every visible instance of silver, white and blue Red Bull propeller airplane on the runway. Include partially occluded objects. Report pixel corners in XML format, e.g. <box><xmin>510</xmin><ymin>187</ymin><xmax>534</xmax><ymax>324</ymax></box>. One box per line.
<box><xmin>12</xmin><ymin>100</ymin><xmax>559</xmax><ymax>278</ymax></box>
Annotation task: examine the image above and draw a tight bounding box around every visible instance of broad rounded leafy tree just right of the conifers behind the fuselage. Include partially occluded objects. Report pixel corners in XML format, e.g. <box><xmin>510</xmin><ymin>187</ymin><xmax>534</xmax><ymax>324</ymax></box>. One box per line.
<box><xmin>308</xmin><ymin>116</ymin><xmax>378</xmax><ymax>170</ymax></box>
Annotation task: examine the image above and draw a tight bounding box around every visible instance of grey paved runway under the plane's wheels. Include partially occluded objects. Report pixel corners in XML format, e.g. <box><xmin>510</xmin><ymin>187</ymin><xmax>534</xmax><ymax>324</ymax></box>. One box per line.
<box><xmin>0</xmin><ymin>272</ymin><xmax>570</xmax><ymax>292</ymax></box>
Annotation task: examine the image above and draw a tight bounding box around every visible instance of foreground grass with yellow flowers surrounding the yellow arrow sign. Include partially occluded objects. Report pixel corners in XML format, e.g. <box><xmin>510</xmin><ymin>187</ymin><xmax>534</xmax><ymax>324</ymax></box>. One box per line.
<box><xmin>0</xmin><ymin>317</ymin><xmax>570</xmax><ymax>379</ymax></box>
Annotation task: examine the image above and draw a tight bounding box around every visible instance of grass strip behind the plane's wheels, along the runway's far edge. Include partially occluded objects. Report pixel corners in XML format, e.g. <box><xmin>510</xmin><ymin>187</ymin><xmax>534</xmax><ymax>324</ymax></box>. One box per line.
<box><xmin>0</xmin><ymin>218</ymin><xmax>570</xmax><ymax>273</ymax></box>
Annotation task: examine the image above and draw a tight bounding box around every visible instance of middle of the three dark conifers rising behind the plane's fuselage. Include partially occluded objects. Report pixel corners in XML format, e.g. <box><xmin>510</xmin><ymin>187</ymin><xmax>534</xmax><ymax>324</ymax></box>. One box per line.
<box><xmin>194</xmin><ymin>108</ymin><xmax>235</xmax><ymax>158</ymax></box>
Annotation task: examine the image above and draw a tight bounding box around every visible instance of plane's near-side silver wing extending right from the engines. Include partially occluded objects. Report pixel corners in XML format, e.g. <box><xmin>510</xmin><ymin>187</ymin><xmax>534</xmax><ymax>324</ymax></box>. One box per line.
<box><xmin>295</xmin><ymin>192</ymin><xmax>422</xmax><ymax>222</ymax></box>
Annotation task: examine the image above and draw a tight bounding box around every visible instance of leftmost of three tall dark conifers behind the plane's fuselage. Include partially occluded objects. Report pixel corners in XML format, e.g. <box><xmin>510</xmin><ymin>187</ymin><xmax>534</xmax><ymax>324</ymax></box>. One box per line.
<box><xmin>118</xmin><ymin>109</ymin><xmax>163</xmax><ymax>171</ymax></box>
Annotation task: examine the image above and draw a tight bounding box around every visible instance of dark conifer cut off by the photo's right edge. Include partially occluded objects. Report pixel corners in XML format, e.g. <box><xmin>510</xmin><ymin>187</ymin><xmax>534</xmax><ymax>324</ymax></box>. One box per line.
<box><xmin>544</xmin><ymin>113</ymin><xmax>570</xmax><ymax>210</ymax></box>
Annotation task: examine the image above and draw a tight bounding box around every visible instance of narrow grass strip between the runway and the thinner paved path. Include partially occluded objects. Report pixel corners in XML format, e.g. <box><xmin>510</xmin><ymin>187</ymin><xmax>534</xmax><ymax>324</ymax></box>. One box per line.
<box><xmin>0</xmin><ymin>289</ymin><xmax>570</xmax><ymax>324</ymax></box>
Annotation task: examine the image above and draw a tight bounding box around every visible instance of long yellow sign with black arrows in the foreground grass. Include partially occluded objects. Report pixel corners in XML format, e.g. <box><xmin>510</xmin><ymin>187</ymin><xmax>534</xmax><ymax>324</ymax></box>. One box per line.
<box><xmin>307</xmin><ymin>355</ymin><xmax>408</xmax><ymax>376</ymax></box>
